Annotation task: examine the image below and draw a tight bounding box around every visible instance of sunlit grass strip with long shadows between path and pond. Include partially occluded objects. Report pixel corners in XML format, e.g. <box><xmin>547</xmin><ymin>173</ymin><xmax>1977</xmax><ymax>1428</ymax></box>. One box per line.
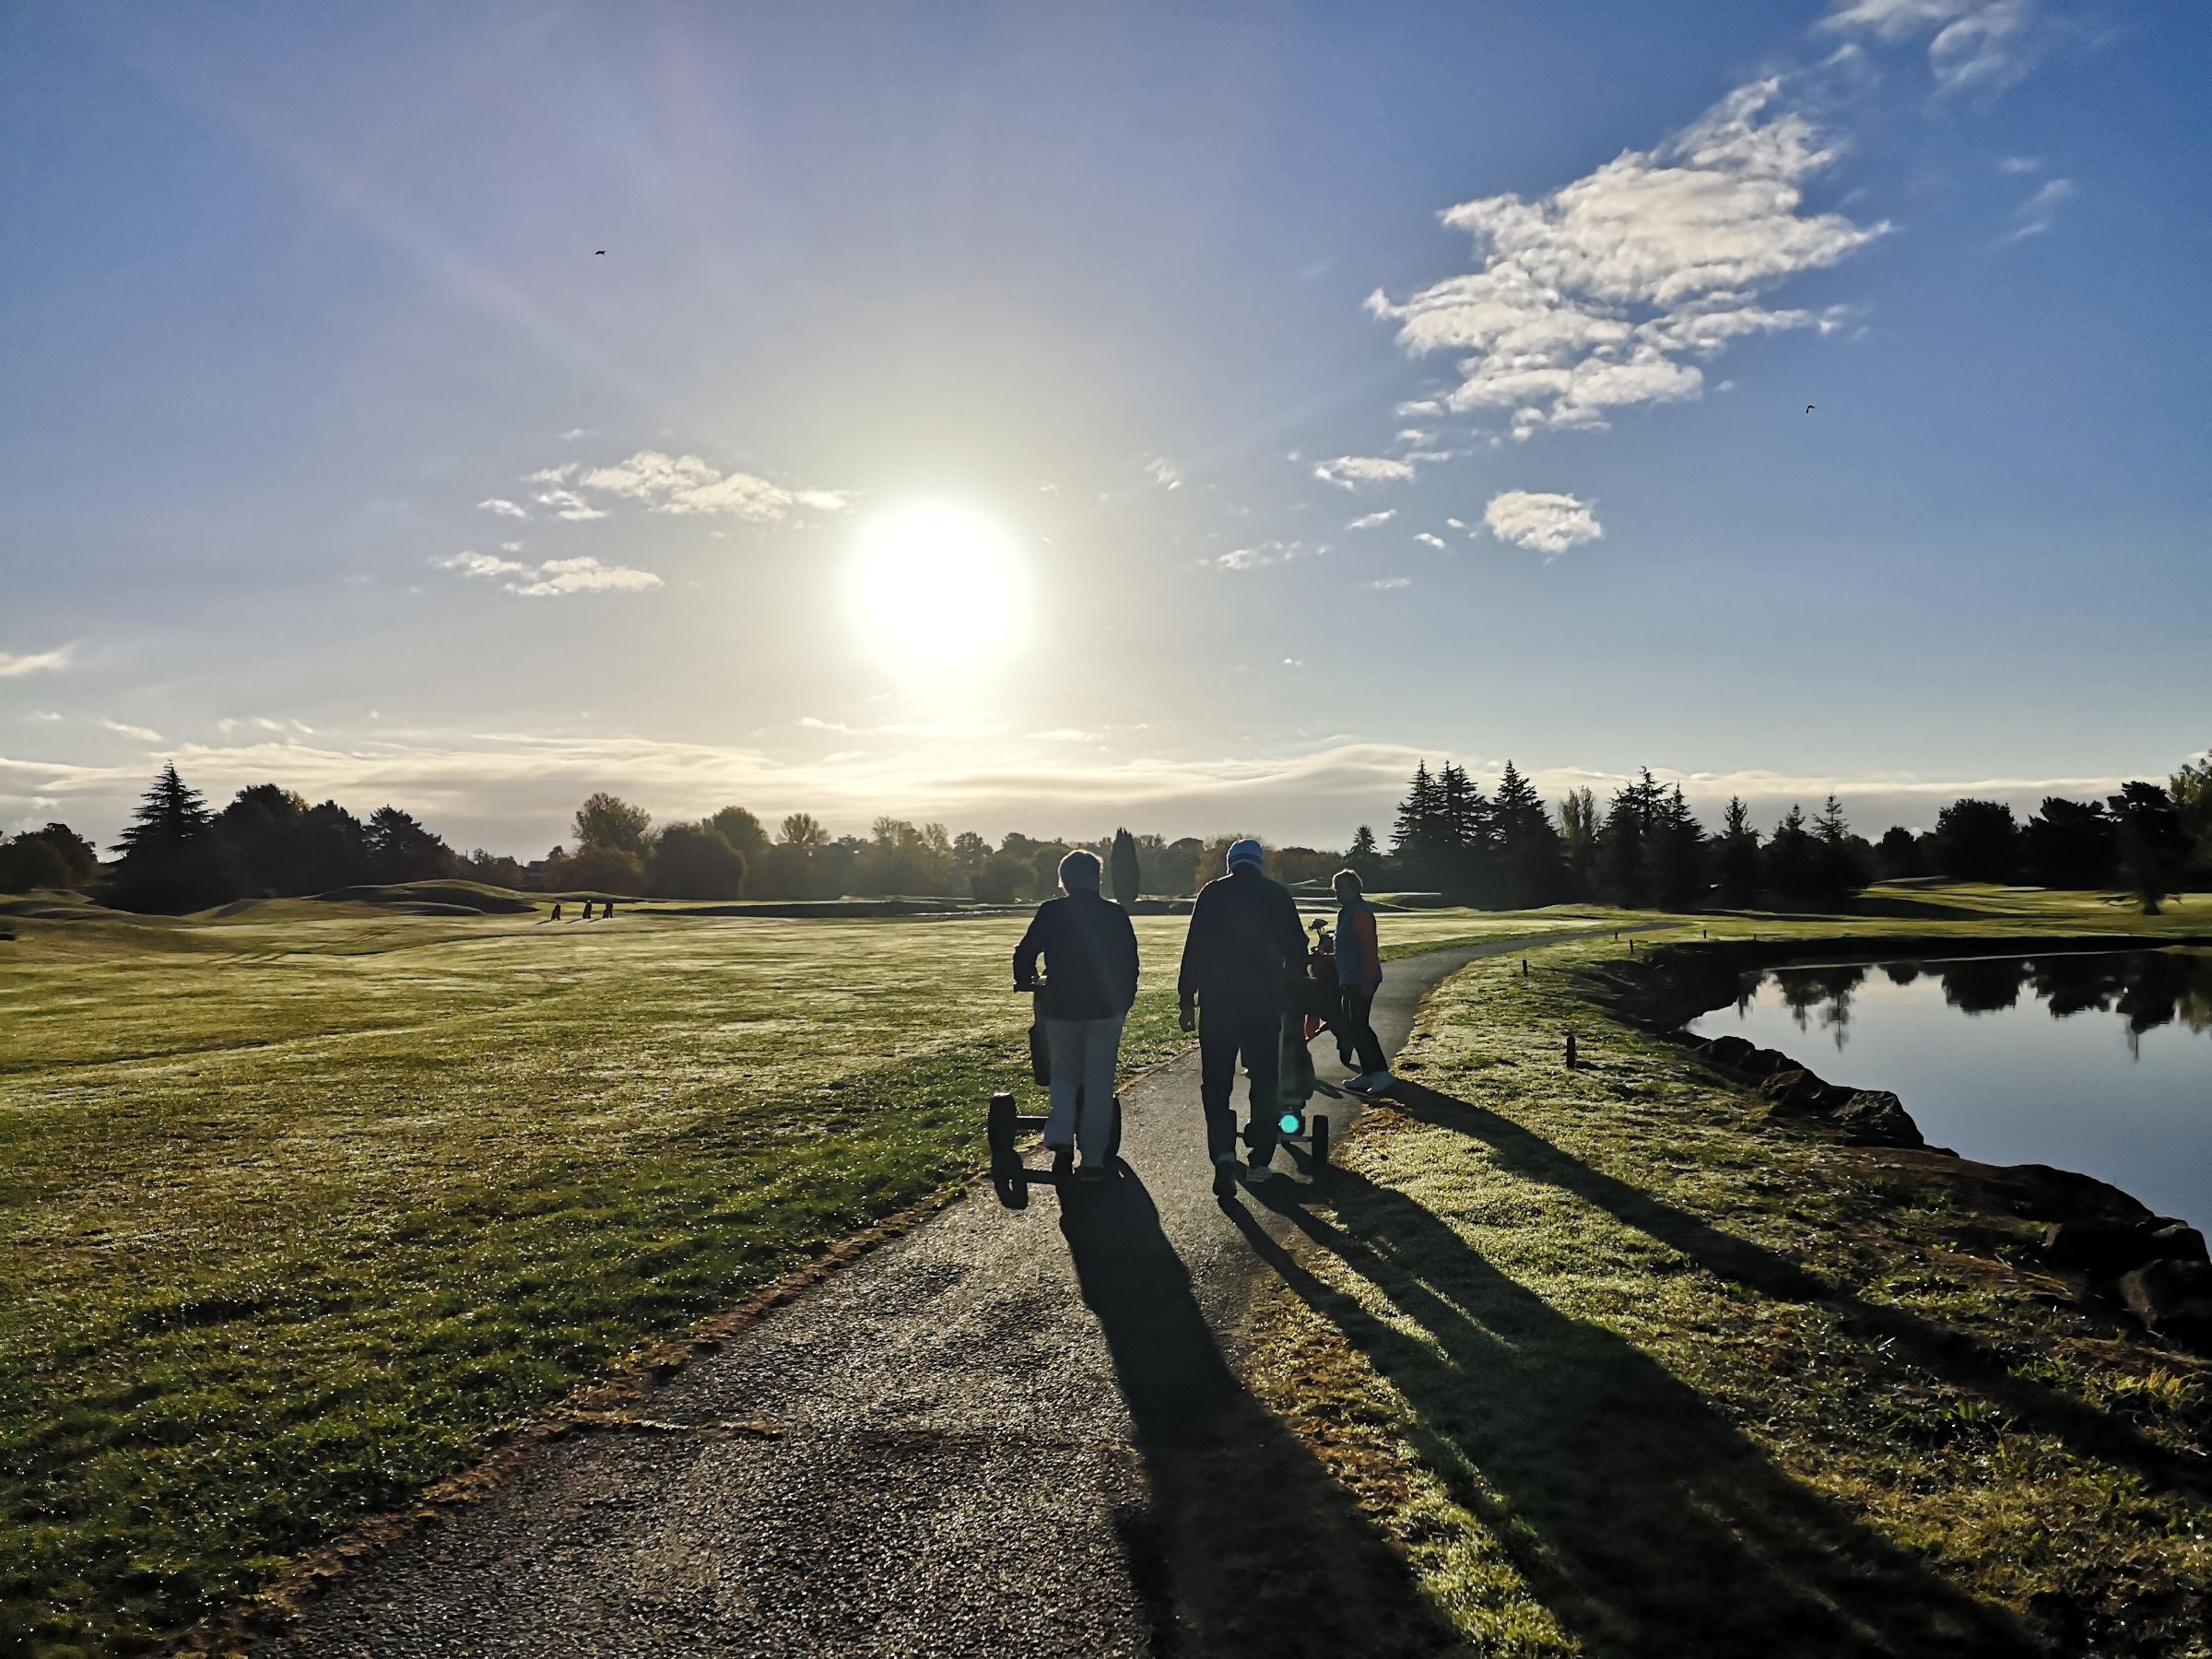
<box><xmin>1256</xmin><ymin>889</ymin><xmax>2212</xmax><ymax>1659</ymax></box>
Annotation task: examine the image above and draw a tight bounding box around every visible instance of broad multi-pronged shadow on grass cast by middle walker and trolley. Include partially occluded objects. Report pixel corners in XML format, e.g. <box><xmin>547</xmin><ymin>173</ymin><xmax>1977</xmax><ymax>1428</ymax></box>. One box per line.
<box><xmin>1237</xmin><ymin>1171</ymin><xmax>2033</xmax><ymax>1659</ymax></box>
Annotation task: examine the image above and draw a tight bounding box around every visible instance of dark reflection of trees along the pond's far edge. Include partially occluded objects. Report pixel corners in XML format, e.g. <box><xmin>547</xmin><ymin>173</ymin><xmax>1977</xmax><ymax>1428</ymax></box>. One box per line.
<box><xmin>1736</xmin><ymin>951</ymin><xmax>2212</xmax><ymax>1053</ymax></box>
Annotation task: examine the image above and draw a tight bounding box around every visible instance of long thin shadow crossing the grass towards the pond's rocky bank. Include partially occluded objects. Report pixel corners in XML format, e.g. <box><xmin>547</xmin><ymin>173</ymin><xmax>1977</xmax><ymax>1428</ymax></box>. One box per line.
<box><xmin>1392</xmin><ymin>1082</ymin><xmax>2206</xmax><ymax>1493</ymax></box>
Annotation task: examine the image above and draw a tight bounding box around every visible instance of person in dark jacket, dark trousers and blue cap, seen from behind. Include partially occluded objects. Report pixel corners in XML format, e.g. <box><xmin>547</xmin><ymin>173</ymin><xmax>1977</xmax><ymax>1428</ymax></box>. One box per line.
<box><xmin>1177</xmin><ymin>841</ymin><xmax>1305</xmax><ymax>1199</ymax></box>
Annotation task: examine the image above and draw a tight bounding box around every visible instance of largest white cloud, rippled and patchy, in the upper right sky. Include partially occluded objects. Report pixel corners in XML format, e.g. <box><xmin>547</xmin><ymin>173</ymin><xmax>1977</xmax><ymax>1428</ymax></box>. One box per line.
<box><xmin>1362</xmin><ymin>77</ymin><xmax>1889</xmax><ymax>442</ymax></box>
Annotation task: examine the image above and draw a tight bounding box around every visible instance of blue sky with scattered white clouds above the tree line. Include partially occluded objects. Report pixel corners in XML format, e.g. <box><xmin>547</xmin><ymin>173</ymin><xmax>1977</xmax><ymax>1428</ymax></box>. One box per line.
<box><xmin>0</xmin><ymin>0</ymin><xmax>2212</xmax><ymax>852</ymax></box>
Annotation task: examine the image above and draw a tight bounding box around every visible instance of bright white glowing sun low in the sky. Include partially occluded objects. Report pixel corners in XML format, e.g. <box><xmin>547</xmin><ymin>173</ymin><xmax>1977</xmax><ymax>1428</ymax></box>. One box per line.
<box><xmin>853</xmin><ymin>507</ymin><xmax>1022</xmax><ymax>668</ymax></box>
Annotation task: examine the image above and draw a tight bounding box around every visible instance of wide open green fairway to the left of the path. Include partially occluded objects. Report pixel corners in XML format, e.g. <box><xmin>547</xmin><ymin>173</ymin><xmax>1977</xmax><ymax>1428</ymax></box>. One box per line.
<box><xmin>0</xmin><ymin>902</ymin><xmax>1593</xmax><ymax>1653</ymax></box>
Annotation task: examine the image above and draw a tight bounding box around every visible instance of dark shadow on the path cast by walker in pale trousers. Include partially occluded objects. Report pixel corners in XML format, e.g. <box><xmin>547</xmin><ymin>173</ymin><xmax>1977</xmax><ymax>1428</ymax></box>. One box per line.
<box><xmin>1060</xmin><ymin>1166</ymin><xmax>1465</xmax><ymax>1659</ymax></box>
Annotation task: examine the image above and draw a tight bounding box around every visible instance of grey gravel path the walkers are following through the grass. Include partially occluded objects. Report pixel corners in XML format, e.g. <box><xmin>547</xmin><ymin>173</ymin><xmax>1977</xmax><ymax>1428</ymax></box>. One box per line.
<box><xmin>256</xmin><ymin>940</ymin><xmax>1574</xmax><ymax>1659</ymax></box>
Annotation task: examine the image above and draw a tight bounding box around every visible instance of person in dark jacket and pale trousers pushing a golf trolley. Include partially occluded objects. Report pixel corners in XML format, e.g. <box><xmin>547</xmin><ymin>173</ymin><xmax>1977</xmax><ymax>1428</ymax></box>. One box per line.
<box><xmin>1013</xmin><ymin>850</ymin><xmax>1137</xmax><ymax>1182</ymax></box>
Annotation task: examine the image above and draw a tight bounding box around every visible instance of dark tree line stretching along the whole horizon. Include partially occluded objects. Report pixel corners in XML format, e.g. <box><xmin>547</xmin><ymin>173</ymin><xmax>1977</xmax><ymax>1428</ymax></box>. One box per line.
<box><xmin>0</xmin><ymin>759</ymin><xmax>2212</xmax><ymax>912</ymax></box>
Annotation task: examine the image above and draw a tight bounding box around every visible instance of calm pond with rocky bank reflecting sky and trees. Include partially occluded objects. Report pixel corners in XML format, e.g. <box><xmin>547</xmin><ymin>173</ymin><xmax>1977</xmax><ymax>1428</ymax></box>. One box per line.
<box><xmin>1690</xmin><ymin>951</ymin><xmax>2212</xmax><ymax>1226</ymax></box>
